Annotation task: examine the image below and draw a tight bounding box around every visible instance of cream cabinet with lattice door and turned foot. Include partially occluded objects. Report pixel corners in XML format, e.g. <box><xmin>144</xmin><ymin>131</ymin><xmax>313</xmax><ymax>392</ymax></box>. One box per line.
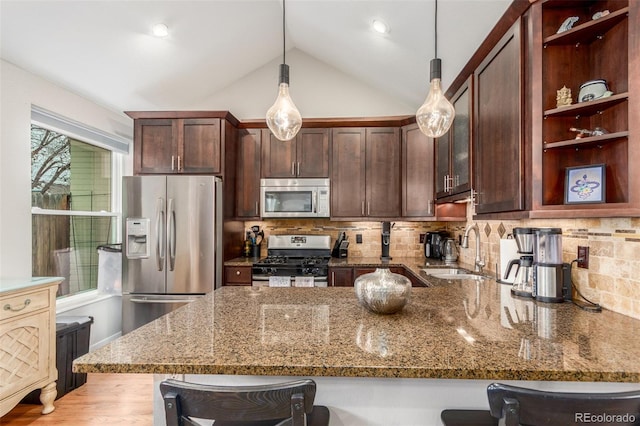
<box><xmin>0</xmin><ymin>278</ymin><xmax>62</xmax><ymax>416</ymax></box>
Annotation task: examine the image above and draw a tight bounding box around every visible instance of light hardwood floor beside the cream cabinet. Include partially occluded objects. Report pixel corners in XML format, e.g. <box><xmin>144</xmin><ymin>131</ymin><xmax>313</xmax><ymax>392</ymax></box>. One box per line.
<box><xmin>0</xmin><ymin>374</ymin><xmax>153</xmax><ymax>426</ymax></box>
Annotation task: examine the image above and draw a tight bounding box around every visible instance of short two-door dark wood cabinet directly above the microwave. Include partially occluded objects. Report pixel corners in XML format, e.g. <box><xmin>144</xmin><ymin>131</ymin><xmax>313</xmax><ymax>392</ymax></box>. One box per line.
<box><xmin>262</xmin><ymin>128</ymin><xmax>329</xmax><ymax>178</ymax></box>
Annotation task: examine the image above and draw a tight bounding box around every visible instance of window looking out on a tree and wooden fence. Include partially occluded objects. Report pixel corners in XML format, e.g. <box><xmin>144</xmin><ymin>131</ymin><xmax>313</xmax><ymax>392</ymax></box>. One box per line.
<box><xmin>31</xmin><ymin>107</ymin><xmax>128</xmax><ymax>297</ymax></box>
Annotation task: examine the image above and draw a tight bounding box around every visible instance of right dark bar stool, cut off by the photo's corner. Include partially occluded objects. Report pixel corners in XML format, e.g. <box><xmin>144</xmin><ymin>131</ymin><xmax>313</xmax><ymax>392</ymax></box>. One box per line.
<box><xmin>440</xmin><ymin>383</ymin><xmax>640</xmax><ymax>426</ymax></box>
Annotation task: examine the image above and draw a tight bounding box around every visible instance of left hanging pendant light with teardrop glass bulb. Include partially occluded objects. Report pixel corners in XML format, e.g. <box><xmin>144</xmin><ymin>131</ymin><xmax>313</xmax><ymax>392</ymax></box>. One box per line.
<box><xmin>267</xmin><ymin>0</ymin><xmax>302</xmax><ymax>141</ymax></box>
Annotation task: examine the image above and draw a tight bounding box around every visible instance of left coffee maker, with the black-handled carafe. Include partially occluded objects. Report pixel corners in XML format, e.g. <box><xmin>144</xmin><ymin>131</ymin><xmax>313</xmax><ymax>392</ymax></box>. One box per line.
<box><xmin>504</xmin><ymin>228</ymin><xmax>535</xmax><ymax>297</ymax></box>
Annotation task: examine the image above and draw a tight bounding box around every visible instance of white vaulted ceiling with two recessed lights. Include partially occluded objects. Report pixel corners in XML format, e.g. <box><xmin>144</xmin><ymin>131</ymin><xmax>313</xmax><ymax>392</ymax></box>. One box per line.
<box><xmin>0</xmin><ymin>0</ymin><xmax>511</xmax><ymax>116</ymax></box>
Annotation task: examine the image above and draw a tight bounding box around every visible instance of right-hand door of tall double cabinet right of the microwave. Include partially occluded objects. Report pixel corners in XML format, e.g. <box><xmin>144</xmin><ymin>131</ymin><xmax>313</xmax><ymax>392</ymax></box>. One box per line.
<box><xmin>366</xmin><ymin>127</ymin><xmax>401</xmax><ymax>217</ymax></box>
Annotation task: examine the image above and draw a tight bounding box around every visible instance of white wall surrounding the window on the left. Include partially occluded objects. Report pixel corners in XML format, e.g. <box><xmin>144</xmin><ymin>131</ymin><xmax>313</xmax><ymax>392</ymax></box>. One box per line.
<box><xmin>0</xmin><ymin>61</ymin><xmax>133</xmax><ymax>347</ymax></box>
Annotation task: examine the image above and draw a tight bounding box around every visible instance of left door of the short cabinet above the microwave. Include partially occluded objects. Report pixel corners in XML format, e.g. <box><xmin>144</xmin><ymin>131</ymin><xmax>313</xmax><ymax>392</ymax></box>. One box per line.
<box><xmin>262</xmin><ymin>130</ymin><xmax>296</xmax><ymax>178</ymax></box>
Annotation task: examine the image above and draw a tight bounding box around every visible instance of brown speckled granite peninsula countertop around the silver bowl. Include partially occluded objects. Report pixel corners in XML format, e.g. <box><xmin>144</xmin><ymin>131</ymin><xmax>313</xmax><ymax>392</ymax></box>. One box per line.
<box><xmin>73</xmin><ymin>272</ymin><xmax>640</xmax><ymax>382</ymax></box>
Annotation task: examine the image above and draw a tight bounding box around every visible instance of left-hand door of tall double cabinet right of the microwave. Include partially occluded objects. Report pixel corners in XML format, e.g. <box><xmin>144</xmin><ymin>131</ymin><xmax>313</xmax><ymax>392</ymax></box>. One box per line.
<box><xmin>331</xmin><ymin>128</ymin><xmax>365</xmax><ymax>217</ymax></box>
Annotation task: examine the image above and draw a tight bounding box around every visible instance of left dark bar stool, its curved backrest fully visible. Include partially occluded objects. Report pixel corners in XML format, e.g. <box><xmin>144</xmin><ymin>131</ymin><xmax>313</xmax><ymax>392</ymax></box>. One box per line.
<box><xmin>160</xmin><ymin>379</ymin><xmax>329</xmax><ymax>426</ymax></box>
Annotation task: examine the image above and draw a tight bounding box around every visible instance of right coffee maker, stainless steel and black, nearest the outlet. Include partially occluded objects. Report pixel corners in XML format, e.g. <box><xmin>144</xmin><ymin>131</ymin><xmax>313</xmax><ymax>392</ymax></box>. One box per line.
<box><xmin>532</xmin><ymin>228</ymin><xmax>571</xmax><ymax>303</ymax></box>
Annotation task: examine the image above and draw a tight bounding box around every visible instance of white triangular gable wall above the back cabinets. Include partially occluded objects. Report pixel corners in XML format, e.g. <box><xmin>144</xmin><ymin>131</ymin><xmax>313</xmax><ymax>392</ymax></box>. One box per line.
<box><xmin>194</xmin><ymin>49</ymin><xmax>416</xmax><ymax>121</ymax></box>
